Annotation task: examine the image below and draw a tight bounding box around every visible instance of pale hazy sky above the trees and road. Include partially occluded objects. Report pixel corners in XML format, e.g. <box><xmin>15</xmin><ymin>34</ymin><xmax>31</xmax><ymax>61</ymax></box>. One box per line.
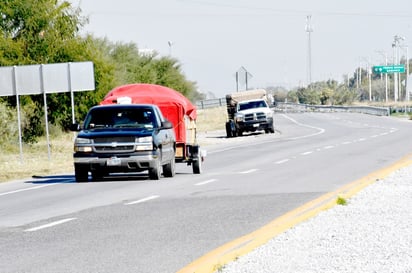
<box><xmin>69</xmin><ymin>0</ymin><xmax>412</xmax><ymax>97</ymax></box>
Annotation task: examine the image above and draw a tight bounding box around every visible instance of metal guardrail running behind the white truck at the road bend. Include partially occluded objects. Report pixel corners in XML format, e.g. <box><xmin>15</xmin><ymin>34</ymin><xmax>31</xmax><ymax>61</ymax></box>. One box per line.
<box><xmin>196</xmin><ymin>98</ymin><xmax>392</xmax><ymax>116</ymax></box>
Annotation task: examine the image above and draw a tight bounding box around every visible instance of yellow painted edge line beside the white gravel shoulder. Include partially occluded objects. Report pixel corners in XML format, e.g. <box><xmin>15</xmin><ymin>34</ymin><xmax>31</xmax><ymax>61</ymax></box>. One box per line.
<box><xmin>176</xmin><ymin>154</ymin><xmax>412</xmax><ymax>273</ymax></box>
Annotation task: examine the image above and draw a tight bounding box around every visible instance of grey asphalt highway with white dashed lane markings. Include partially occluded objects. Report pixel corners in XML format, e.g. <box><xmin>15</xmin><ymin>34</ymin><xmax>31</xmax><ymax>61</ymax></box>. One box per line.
<box><xmin>0</xmin><ymin>113</ymin><xmax>412</xmax><ymax>273</ymax></box>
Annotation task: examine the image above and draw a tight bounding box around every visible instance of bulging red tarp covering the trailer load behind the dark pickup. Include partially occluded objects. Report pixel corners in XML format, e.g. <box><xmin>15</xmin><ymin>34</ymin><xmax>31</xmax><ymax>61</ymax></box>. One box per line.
<box><xmin>100</xmin><ymin>83</ymin><xmax>196</xmax><ymax>142</ymax></box>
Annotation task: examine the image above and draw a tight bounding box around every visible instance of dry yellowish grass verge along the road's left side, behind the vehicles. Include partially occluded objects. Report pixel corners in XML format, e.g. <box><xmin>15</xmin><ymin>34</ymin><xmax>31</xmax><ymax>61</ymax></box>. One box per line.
<box><xmin>0</xmin><ymin>107</ymin><xmax>227</xmax><ymax>182</ymax></box>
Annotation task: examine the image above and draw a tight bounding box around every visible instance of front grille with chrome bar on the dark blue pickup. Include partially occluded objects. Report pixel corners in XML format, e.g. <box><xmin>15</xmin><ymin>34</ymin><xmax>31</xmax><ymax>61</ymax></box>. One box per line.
<box><xmin>94</xmin><ymin>137</ymin><xmax>135</xmax><ymax>153</ymax></box>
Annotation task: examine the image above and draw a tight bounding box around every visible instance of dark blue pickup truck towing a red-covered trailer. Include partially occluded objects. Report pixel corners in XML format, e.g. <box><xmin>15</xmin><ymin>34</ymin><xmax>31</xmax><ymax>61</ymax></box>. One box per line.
<box><xmin>71</xmin><ymin>104</ymin><xmax>176</xmax><ymax>182</ymax></box>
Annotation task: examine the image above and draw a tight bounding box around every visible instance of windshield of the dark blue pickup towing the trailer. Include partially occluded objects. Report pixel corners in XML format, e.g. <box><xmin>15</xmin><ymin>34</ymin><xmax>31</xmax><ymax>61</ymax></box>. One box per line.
<box><xmin>83</xmin><ymin>108</ymin><xmax>158</xmax><ymax>130</ymax></box>
